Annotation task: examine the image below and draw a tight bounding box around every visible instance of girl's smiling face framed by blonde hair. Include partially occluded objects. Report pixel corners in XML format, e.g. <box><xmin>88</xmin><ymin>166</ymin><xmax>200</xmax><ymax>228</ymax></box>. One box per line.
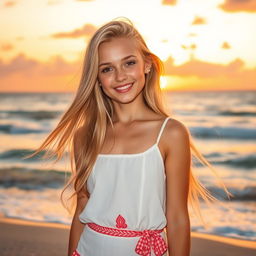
<box><xmin>98</xmin><ymin>38</ymin><xmax>151</xmax><ymax>103</ymax></box>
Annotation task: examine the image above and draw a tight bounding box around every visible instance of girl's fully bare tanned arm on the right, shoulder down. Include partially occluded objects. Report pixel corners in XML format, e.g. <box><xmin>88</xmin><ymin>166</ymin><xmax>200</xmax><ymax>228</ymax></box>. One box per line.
<box><xmin>165</xmin><ymin>120</ymin><xmax>191</xmax><ymax>256</ymax></box>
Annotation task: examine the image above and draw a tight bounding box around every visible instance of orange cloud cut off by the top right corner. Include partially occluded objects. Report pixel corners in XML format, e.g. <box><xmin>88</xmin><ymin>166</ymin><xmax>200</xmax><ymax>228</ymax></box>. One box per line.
<box><xmin>219</xmin><ymin>0</ymin><xmax>256</xmax><ymax>12</ymax></box>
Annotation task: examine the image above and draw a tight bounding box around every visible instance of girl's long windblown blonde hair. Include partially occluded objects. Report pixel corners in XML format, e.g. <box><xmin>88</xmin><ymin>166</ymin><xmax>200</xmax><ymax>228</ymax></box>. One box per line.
<box><xmin>24</xmin><ymin>20</ymin><xmax>232</xmax><ymax>225</ymax></box>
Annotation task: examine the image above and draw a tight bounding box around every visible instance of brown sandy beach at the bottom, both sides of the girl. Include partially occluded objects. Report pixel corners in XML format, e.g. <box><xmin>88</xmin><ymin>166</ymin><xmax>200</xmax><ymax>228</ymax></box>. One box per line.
<box><xmin>0</xmin><ymin>218</ymin><xmax>256</xmax><ymax>256</ymax></box>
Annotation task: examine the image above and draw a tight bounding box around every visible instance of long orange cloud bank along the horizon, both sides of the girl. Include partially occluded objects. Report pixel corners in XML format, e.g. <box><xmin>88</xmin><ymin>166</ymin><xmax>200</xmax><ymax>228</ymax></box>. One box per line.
<box><xmin>0</xmin><ymin>54</ymin><xmax>256</xmax><ymax>92</ymax></box>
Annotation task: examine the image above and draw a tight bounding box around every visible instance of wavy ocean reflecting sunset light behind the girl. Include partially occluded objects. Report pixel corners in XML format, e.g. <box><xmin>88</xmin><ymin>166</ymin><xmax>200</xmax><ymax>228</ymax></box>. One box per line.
<box><xmin>0</xmin><ymin>91</ymin><xmax>256</xmax><ymax>241</ymax></box>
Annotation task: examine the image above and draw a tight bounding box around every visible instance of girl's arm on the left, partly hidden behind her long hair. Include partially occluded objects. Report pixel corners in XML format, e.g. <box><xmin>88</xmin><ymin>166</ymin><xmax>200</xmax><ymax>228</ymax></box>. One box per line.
<box><xmin>68</xmin><ymin>129</ymin><xmax>88</xmax><ymax>256</ymax></box>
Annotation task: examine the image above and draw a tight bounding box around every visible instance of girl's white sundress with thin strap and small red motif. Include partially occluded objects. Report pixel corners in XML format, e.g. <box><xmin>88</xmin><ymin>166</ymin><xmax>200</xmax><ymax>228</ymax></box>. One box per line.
<box><xmin>74</xmin><ymin>117</ymin><xmax>170</xmax><ymax>256</ymax></box>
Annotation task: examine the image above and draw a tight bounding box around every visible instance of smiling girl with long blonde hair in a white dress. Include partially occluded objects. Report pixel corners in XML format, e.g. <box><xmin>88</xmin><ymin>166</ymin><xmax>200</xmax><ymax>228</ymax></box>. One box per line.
<box><xmin>28</xmin><ymin>18</ymin><xmax>230</xmax><ymax>256</ymax></box>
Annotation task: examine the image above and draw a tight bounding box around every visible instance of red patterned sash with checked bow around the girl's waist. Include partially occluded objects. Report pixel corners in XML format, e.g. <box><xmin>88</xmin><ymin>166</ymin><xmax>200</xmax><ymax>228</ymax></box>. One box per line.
<box><xmin>87</xmin><ymin>223</ymin><xmax>167</xmax><ymax>256</ymax></box>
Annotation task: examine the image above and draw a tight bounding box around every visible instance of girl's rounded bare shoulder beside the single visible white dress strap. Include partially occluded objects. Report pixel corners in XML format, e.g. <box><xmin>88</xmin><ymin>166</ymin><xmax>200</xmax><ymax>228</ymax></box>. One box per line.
<box><xmin>162</xmin><ymin>118</ymin><xmax>190</xmax><ymax>154</ymax></box>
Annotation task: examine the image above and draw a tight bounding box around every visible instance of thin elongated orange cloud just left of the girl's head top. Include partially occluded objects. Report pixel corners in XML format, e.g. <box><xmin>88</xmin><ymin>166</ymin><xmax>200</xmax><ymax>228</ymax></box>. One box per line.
<box><xmin>52</xmin><ymin>24</ymin><xmax>96</xmax><ymax>39</ymax></box>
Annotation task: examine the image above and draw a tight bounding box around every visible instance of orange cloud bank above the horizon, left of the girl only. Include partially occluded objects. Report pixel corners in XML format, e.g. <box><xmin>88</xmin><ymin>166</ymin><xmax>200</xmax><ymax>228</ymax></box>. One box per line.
<box><xmin>0</xmin><ymin>54</ymin><xmax>82</xmax><ymax>92</ymax></box>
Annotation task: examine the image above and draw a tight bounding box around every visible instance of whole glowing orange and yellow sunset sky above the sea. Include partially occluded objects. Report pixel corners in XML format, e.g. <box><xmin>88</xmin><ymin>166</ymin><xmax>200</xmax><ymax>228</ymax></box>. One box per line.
<box><xmin>0</xmin><ymin>0</ymin><xmax>256</xmax><ymax>92</ymax></box>
